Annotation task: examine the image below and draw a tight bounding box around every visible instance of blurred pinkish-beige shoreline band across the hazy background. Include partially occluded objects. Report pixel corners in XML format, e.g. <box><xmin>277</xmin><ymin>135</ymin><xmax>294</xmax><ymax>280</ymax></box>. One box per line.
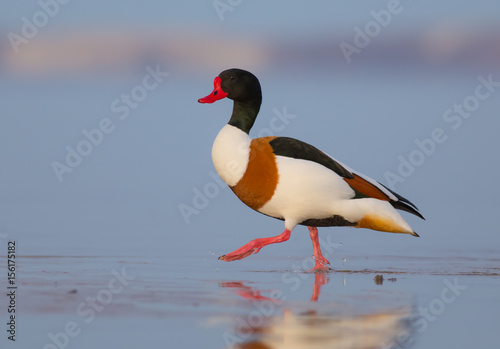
<box><xmin>0</xmin><ymin>23</ymin><xmax>500</xmax><ymax>78</ymax></box>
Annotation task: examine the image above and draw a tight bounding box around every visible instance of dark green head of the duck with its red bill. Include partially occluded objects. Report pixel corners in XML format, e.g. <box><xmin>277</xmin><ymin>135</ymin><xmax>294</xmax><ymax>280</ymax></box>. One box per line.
<box><xmin>198</xmin><ymin>68</ymin><xmax>262</xmax><ymax>107</ymax></box>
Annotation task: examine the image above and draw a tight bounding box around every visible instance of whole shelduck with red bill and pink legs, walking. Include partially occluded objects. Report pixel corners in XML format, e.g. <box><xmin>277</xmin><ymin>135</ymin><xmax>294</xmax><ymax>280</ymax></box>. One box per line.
<box><xmin>198</xmin><ymin>68</ymin><xmax>425</xmax><ymax>271</ymax></box>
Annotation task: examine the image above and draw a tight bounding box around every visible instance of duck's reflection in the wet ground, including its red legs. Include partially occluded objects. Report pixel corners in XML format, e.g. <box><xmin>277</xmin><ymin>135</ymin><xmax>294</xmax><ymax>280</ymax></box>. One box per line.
<box><xmin>220</xmin><ymin>272</ymin><xmax>412</xmax><ymax>349</ymax></box>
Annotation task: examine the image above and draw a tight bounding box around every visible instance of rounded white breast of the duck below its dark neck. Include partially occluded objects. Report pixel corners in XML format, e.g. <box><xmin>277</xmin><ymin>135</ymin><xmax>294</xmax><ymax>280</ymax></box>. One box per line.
<box><xmin>212</xmin><ymin>125</ymin><xmax>251</xmax><ymax>186</ymax></box>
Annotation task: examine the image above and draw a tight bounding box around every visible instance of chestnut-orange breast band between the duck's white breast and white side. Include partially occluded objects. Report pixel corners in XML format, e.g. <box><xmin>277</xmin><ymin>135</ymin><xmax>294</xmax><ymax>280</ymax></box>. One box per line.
<box><xmin>231</xmin><ymin>137</ymin><xmax>278</xmax><ymax>210</ymax></box>
